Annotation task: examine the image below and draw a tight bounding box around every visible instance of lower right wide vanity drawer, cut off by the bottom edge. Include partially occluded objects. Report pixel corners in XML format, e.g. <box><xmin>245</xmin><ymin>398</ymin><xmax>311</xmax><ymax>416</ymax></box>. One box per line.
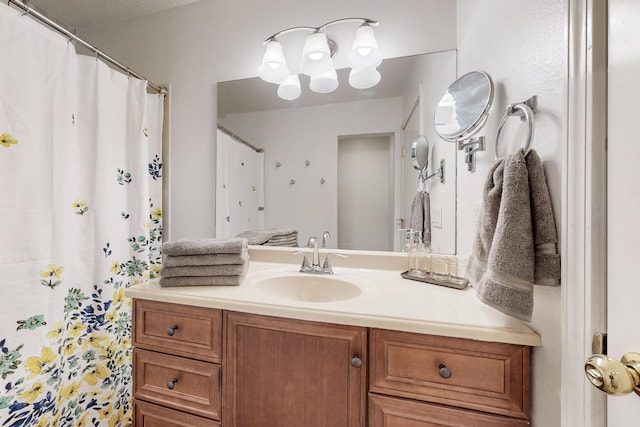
<box><xmin>369</xmin><ymin>394</ymin><xmax>529</xmax><ymax>427</ymax></box>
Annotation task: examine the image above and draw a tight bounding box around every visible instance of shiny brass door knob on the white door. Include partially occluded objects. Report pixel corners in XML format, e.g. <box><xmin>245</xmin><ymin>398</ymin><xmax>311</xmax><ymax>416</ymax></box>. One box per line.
<box><xmin>584</xmin><ymin>353</ymin><xmax>640</xmax><ymax>396</ymax></box>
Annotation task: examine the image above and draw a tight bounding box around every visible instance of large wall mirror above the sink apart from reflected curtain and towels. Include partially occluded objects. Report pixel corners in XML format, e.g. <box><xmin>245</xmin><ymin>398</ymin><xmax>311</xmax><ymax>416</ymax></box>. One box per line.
<box><xmin>217</xmin><ymin>51</ymin><xmax>457</xmax><ymax>254</ymax></box>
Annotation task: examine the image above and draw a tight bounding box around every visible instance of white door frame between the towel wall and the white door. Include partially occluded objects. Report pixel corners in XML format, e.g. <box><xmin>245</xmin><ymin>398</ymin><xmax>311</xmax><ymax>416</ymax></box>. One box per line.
<box><xmin>561</xmin><ymin>0</ymin><xmax>608</xmax><ymax>427</ymax></box>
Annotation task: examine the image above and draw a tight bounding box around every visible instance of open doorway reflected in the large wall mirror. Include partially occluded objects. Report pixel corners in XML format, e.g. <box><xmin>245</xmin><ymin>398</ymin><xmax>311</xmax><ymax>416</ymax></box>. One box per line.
<box><xmin>337</xmin><ymin>135</ymin><xmax>395</xmax><ymax>251</ymax></box>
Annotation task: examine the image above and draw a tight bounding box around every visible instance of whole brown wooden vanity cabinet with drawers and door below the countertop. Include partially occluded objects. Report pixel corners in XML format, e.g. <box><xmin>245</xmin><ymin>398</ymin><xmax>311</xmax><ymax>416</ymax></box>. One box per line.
<box><xmin>133</xmin><ymin>299</ymin><xmax>531</xmax><ymax>427</ymax></box>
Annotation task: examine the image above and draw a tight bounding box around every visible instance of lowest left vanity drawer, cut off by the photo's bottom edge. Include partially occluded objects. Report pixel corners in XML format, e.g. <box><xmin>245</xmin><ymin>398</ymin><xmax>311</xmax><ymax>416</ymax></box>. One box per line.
<box><xmin>133</xmin><ymin>400</ymin><xmax>222</xmax><ymax>427</ymax></box>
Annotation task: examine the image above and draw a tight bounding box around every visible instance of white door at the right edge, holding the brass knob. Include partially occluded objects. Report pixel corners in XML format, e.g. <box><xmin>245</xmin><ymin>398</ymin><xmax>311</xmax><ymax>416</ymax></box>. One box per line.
<box><xmin>607</xmin><ymin>0</ymin><xmax>640</xmax><ymax>427</ymax></box>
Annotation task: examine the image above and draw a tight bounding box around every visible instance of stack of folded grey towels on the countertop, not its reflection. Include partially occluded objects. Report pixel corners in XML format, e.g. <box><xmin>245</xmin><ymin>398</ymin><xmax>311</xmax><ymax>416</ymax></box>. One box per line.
<box><xmin>160</xmin><ymin>238</ymin><xmax>249</xmax><ymax>287</ymax></box>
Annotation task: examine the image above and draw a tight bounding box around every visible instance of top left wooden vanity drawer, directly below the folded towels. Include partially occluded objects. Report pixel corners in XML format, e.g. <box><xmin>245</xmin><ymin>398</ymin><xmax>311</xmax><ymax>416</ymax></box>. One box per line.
<box><xmin>133</xmin><ymin>299</ymin><xmax>222</xmax><ymax>363</ymax></box>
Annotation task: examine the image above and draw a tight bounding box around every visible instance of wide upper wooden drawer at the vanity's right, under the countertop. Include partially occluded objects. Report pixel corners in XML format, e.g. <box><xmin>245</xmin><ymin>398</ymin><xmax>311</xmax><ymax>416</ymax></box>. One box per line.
<box><xmin>370</xmin><ymin>329</ymin><xmax>531</xmax><ymax>419</ymax></box>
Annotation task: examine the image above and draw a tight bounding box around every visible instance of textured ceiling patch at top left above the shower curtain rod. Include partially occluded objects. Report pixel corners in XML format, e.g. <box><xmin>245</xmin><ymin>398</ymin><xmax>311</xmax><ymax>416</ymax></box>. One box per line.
<box><xmin>28</xmin><ymin>0</ymin><xmax>198</xmax><ymax>31</ymax></box>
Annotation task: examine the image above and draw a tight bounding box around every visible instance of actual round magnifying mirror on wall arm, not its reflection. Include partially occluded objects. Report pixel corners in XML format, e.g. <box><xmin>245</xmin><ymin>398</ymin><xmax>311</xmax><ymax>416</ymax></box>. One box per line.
<box><xmin>434</xmin><ymin>71</ymin><xmax>493</xmax><ymax>142</ymax></box>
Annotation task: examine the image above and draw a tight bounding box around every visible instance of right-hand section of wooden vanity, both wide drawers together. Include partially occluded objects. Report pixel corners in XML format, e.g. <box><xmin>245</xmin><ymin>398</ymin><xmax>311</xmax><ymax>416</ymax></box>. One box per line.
<box><xmin>369</xmin><ymin>329</ymin><xmax>531</xmax><ymax>427</ymax></box>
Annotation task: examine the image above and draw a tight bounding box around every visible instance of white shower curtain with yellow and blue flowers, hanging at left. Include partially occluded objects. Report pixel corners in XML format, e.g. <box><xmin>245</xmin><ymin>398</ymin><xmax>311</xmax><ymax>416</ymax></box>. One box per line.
<box><xmin>0</xmin><ymin>4</ymin><xmax>163</xmax><ymax>427</ymax></box>
